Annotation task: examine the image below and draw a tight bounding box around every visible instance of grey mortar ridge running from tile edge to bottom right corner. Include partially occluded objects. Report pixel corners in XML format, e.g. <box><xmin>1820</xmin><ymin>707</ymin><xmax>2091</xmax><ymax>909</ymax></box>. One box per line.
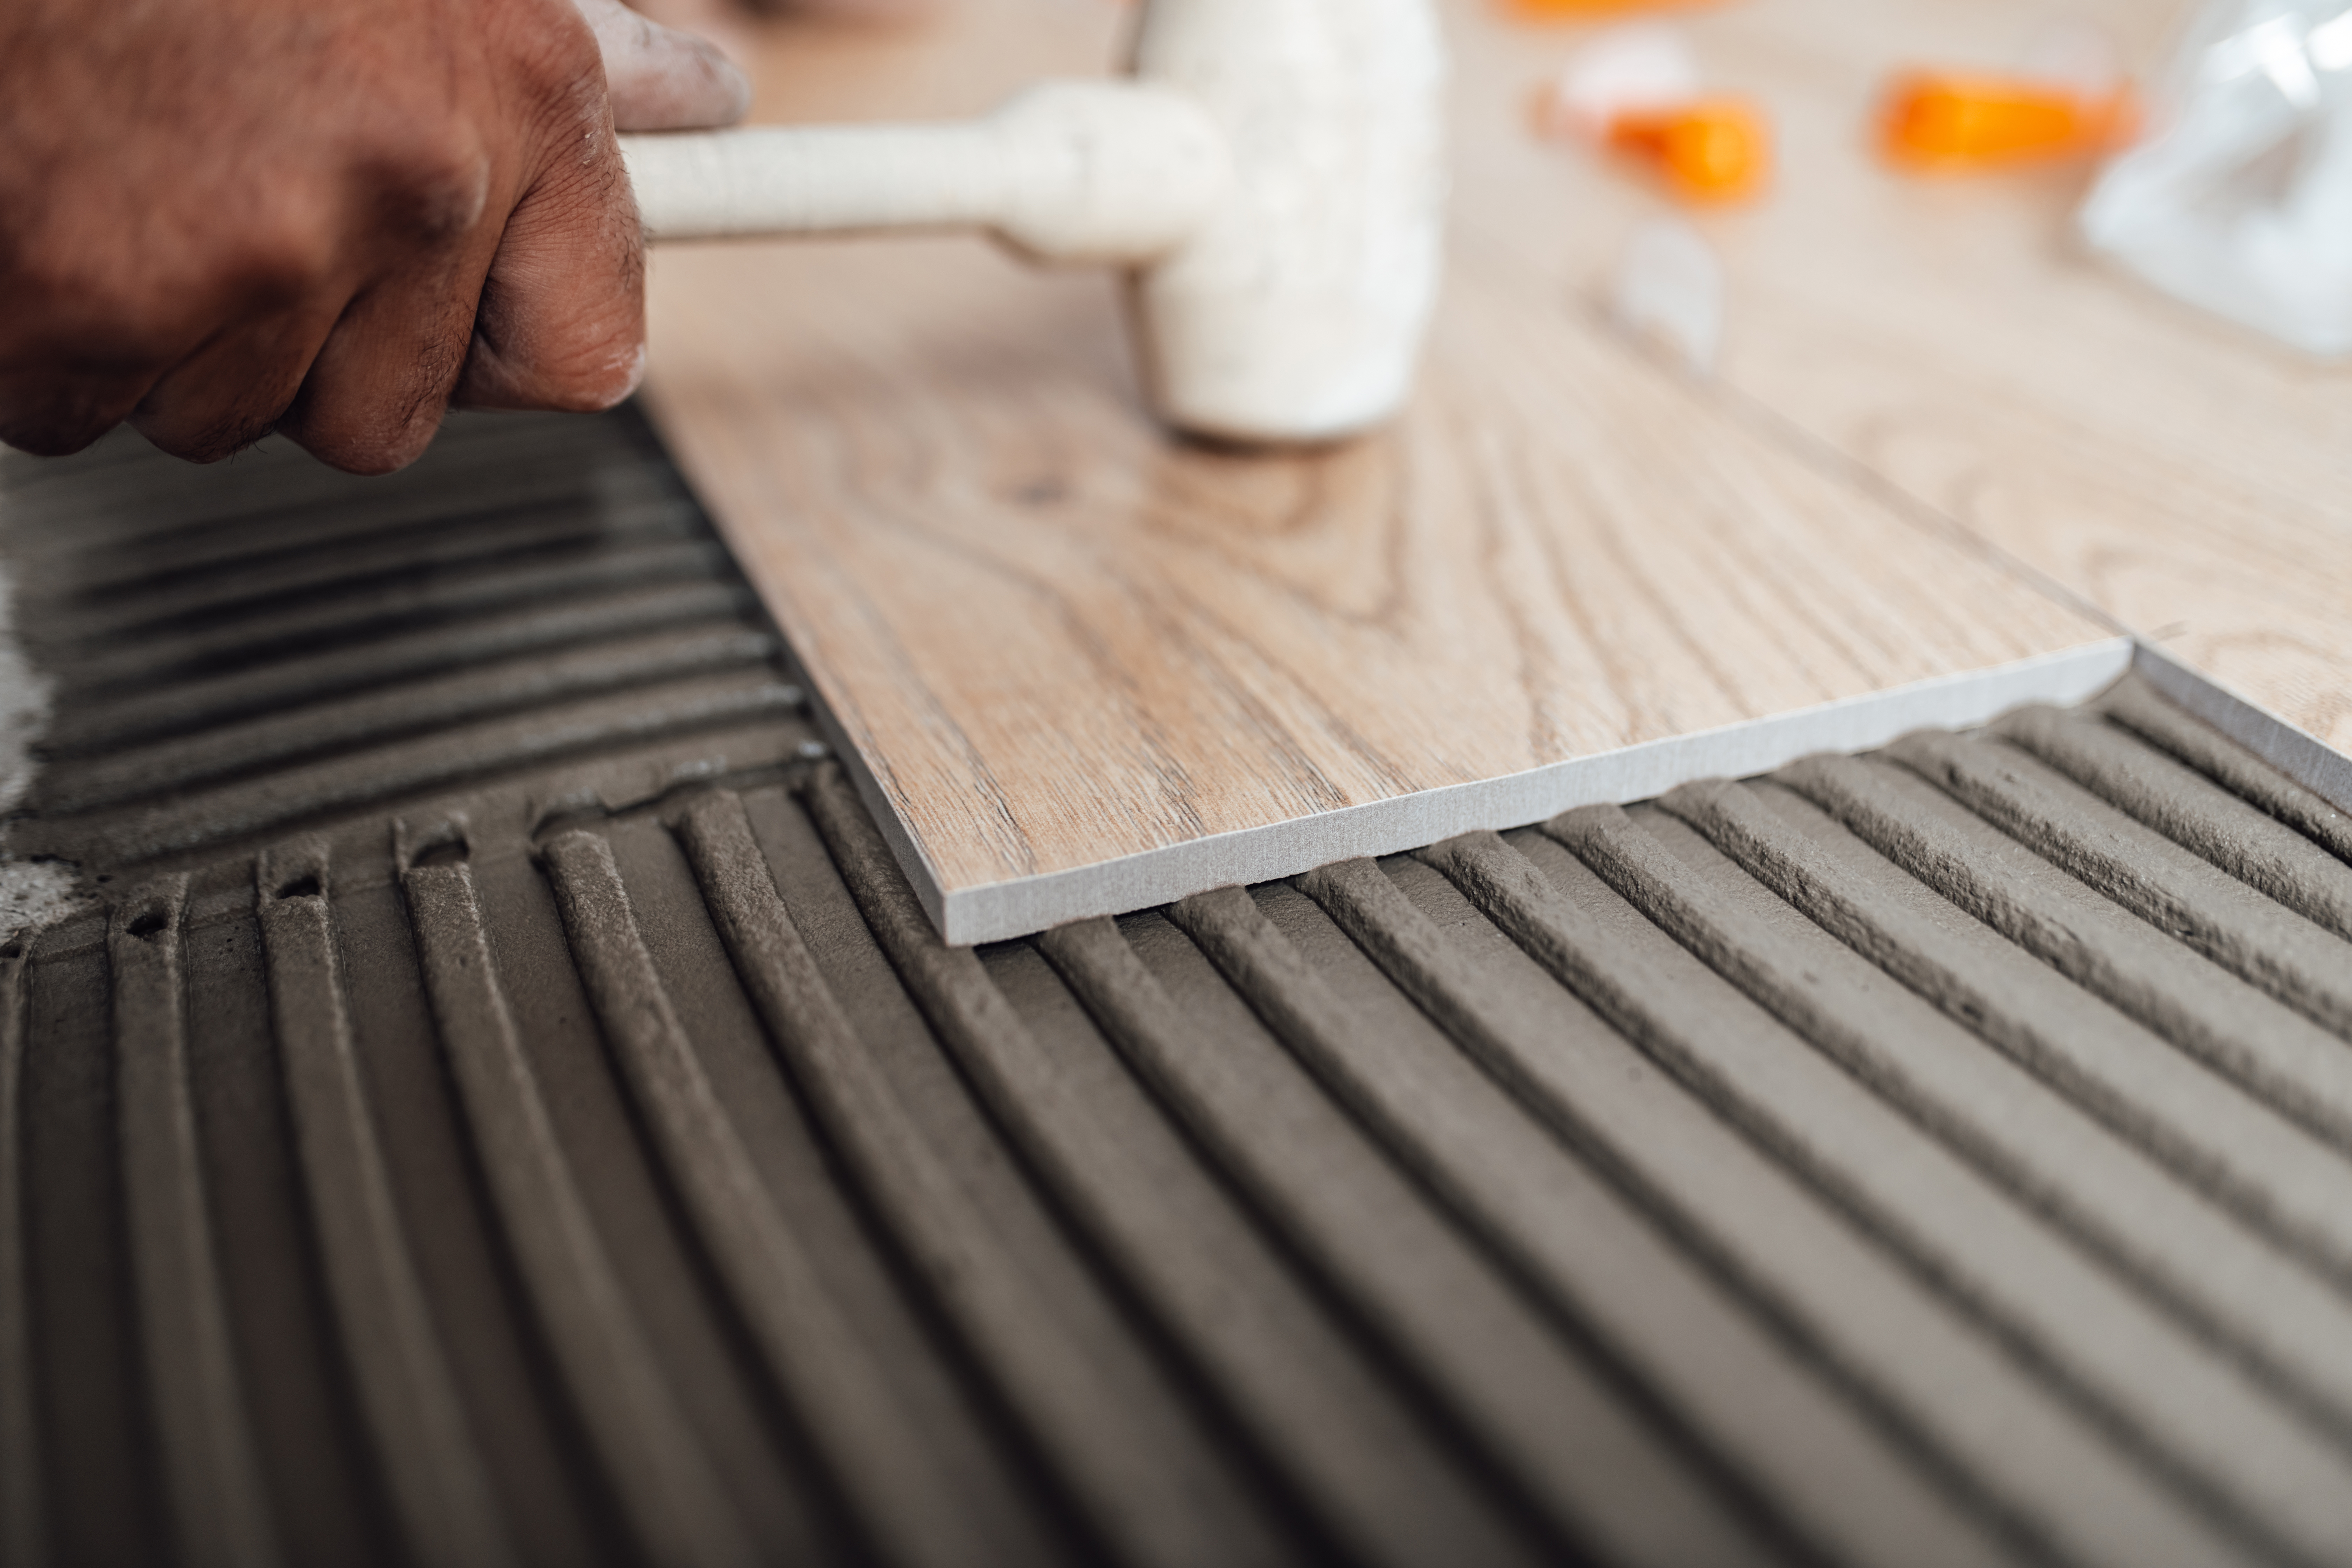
<box><xmin>1486</xmin><ymin>822</ymin><xmax>2352</xmax><ymax>1556</ymax></box>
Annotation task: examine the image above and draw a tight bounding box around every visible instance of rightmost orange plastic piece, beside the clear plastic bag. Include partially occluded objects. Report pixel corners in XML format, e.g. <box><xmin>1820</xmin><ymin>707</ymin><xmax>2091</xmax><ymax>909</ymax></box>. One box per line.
<box><xmin>1879</xmin><ymin>70</ymin><xmax>2138</xmax><ymax>174</ymax></box>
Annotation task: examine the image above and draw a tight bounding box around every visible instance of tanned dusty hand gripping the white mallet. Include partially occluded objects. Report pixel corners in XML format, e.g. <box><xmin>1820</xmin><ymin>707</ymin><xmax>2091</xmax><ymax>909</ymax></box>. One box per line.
<box><xmin>0</xmin><ymin>0</ymin><xmax>748</xmax><ymax>472</ymax></box>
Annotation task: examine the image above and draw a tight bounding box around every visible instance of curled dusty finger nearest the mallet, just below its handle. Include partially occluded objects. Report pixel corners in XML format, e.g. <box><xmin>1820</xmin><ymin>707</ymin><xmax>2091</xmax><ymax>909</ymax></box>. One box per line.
<box><xmin>456</xmin><ymin>115</ymin><xmax>644</xmax><ymax>411</ymax></box>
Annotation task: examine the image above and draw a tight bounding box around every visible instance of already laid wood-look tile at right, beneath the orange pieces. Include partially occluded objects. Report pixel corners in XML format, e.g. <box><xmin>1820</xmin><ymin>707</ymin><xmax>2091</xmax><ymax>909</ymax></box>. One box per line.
<box><xmin>1456</xmin><ymin>0</ymin><xmax>2352</xmax><ymax>750</ymax></box>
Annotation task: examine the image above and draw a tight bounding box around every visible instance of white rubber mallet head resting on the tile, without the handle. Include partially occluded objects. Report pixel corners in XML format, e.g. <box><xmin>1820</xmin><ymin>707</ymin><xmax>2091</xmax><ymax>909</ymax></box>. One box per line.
<box><xmin>1131</xmin><ymin>0</ymin><xmax>1447</xmax><ymax>442</ymax></box>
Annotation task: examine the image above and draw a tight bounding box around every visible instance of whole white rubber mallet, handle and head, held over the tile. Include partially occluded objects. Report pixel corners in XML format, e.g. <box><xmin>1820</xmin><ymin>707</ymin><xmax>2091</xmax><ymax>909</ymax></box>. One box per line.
<box><xmin>621</xmin><ymin>0</ymin><xmax>1447</xmax><ymax>444</ymax></box>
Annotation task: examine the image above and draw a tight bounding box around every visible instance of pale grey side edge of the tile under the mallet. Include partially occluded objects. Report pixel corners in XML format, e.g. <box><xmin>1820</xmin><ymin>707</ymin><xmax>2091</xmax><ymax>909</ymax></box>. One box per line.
<box><xmin>889</xmin><ymin>637</ymin><xmax>2145</xmax><ymax>947</ymax></box>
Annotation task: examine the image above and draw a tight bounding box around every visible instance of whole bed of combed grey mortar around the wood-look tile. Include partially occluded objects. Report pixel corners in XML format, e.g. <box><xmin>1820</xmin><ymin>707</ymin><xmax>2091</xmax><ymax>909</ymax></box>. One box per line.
<box><xmin>0</xmin><ymin>411</ymin><xmax>2352</xmax><ymax>1563</ymax></box>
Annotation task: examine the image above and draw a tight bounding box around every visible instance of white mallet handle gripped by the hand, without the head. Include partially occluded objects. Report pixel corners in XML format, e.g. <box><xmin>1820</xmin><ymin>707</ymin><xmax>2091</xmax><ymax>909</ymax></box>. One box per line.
<box><xmin>621</xmin><ymin>82</ymin><xmax>1228</xmax><ymax>263</ymax></box>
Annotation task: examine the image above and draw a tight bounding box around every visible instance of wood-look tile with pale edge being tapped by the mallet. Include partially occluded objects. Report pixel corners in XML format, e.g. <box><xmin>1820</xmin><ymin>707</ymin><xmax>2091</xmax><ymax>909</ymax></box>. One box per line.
<box><xmin>651</xmin><ymin>0</ymin><xmax>2129</xmax><ymax>940</ymax></box>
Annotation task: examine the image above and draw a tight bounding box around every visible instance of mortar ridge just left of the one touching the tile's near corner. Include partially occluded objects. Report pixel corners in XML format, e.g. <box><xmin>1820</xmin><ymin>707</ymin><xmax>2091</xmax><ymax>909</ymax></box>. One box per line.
<box><xmin>680</xmin><ymin>792</ymin><xmax>1284</xmax><ymax>1568</ymax></box>
